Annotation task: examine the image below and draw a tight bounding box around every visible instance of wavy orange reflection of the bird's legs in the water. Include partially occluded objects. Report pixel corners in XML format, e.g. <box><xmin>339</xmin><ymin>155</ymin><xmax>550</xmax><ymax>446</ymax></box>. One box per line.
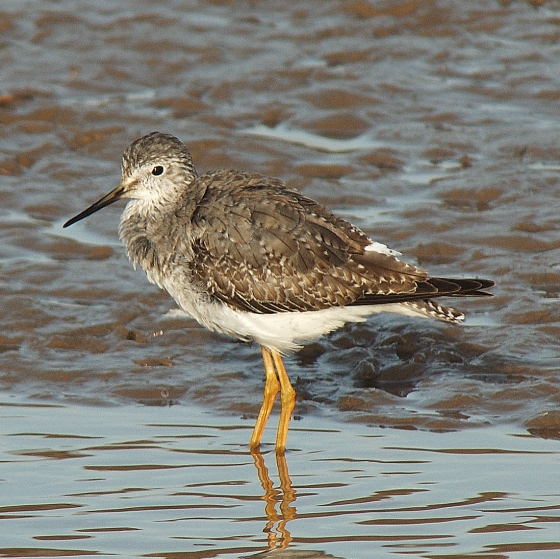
<box><xmin>251</xmin><ymin>450</ymin><xmax>297</xmax><ymax>549</ymax></box>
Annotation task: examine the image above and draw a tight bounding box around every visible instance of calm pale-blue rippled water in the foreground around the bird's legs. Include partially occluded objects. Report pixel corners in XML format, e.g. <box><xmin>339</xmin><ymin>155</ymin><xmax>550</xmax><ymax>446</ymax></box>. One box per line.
<box><xmin>0</xmin><ymin>403</ymin><xmax>560</xmax><ymax>558</ymax></box>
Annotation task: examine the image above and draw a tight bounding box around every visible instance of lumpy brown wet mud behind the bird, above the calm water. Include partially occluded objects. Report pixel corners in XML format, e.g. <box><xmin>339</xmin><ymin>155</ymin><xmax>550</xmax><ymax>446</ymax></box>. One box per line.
<box><xmin>0</xmin><ymin>0</ymin><xmax>560</xmax><ymax>557</ymax></box>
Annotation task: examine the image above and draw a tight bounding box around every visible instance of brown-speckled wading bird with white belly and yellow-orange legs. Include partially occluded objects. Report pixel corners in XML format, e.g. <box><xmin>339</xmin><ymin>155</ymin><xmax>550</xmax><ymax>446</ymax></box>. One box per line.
<box><xmin>63</xmin><ymin>132</ymin><xmax>494</xmax><ymax>456</ymax></box>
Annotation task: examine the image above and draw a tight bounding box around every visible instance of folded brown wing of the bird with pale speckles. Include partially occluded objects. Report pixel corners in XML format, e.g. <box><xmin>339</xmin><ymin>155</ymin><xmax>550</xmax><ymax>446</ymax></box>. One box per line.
<box><xmin>182</xmin><ymin>171</ymin><xmax>474</xmax><ymax>313</ymax></box>
